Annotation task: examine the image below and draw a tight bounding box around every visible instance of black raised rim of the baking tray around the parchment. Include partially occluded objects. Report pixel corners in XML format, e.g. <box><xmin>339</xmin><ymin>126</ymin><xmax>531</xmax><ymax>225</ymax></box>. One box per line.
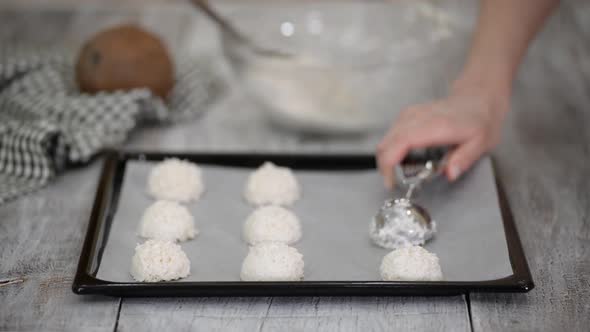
<box><xmin>72</xmin><ymin>150</ymin><xmax>534</xmax><ymax>297</ymax></box>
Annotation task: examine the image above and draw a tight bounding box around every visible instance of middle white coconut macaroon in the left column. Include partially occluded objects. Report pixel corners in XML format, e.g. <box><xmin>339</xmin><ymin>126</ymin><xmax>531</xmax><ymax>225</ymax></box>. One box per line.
<box><xmin>139</xmin><ymin>201</ymin><xmax>199</xmax><ymax>241</ymax></box>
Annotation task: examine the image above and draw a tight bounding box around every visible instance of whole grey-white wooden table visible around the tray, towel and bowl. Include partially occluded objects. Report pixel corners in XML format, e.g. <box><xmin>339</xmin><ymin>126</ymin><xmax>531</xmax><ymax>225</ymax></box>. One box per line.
<box><xmin>0</xmin><ymin>1</ymin><xmax>590</xmax><ymax>331</ymax></box>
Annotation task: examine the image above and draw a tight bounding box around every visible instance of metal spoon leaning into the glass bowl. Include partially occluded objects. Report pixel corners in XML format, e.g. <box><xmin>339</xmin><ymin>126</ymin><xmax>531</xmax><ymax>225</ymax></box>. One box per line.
<box><xmin>190</xmin><ymin>0</ymin><xmax>293</xmax><ymax>58</ymax></box>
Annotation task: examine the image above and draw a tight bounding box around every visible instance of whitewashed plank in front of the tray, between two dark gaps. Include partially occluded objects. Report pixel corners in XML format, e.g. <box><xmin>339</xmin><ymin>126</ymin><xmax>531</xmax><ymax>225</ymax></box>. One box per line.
<box><xmin>119</xmin><ymin>296</ymin><xmax>469</xmax><ymax>331</ymax></box>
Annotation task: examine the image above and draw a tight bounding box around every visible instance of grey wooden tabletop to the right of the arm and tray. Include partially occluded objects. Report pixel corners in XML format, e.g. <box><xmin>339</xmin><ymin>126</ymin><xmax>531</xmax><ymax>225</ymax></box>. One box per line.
<box><xmin>470</xmin><ymin>1</ymin><xmax>590</xmax><ymax>331</ymax></box>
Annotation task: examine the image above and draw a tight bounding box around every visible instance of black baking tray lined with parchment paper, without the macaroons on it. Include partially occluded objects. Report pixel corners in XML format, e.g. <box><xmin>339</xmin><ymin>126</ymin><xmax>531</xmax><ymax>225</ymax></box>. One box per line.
<box><xmin>72</xmin><ymin>151</ymin><xmax>534</xmax><ymax>297</ymax></box>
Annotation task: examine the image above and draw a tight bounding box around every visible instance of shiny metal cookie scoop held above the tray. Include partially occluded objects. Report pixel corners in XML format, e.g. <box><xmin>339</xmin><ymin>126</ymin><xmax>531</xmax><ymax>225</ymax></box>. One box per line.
<box><xmin>369</xmin><ymin>148</ymin><xmax>447</xmax><ymax>249</ymax></box>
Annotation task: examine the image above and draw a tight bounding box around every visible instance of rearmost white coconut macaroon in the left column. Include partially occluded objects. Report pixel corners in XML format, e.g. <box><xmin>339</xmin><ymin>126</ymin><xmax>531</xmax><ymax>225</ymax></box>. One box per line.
<box><xmin>148</xmin><ymin>158</ymin><xmax>205</xmax><ymax>203</ymax></box>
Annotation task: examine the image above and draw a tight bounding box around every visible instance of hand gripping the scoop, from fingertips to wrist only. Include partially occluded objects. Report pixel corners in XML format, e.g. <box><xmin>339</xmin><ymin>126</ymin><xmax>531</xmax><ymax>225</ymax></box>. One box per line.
<box><xmin>377</xmin><ymin>83</ymin><xmax>510</xmax><ymax>189</ymax></box>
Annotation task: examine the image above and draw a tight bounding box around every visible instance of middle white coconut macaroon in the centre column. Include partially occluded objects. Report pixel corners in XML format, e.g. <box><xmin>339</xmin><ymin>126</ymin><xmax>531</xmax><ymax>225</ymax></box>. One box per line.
<box><xmin>243</xmin><ymin>205</ymin><xmax>301</xmax><ymax>245</ymax></box>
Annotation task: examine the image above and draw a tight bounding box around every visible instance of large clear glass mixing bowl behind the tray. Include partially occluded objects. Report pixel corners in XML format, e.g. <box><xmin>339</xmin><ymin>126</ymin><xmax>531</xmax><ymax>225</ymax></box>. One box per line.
<box><xmin>221</xmin><ymin>0</ymin><xmax>458</xmax><ymax>134</ymax></box>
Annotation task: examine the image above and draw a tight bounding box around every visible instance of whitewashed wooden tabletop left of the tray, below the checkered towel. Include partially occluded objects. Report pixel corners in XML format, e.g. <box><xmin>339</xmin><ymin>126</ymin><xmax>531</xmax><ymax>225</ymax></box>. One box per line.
<box><xmin>0</xmin><ymin>163</ymin><xmax>119</xmax><ymax>331</ymax></box>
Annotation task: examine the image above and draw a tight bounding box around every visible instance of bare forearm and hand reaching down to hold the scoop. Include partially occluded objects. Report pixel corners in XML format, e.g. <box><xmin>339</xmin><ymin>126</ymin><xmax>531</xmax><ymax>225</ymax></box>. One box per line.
<box><xmin>377</xmin><ymin>0</ymin><xmax>559</xmax><ymax>187</ymax></box>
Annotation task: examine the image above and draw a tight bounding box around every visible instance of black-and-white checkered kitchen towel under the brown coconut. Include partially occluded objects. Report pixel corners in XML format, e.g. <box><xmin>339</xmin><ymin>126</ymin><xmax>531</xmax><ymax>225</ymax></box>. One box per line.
<box><xmin>0</xmin><ymin>48</ymin><xmax>223</xmax><ymax>204</ymax></box>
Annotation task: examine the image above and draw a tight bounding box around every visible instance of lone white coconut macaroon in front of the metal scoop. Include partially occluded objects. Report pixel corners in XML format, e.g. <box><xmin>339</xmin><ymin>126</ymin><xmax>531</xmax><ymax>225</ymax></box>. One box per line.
<box><xmin>380</xmin><ymin>246</ymin><xmax>443</xmax><ymax>281</ymax></box>
